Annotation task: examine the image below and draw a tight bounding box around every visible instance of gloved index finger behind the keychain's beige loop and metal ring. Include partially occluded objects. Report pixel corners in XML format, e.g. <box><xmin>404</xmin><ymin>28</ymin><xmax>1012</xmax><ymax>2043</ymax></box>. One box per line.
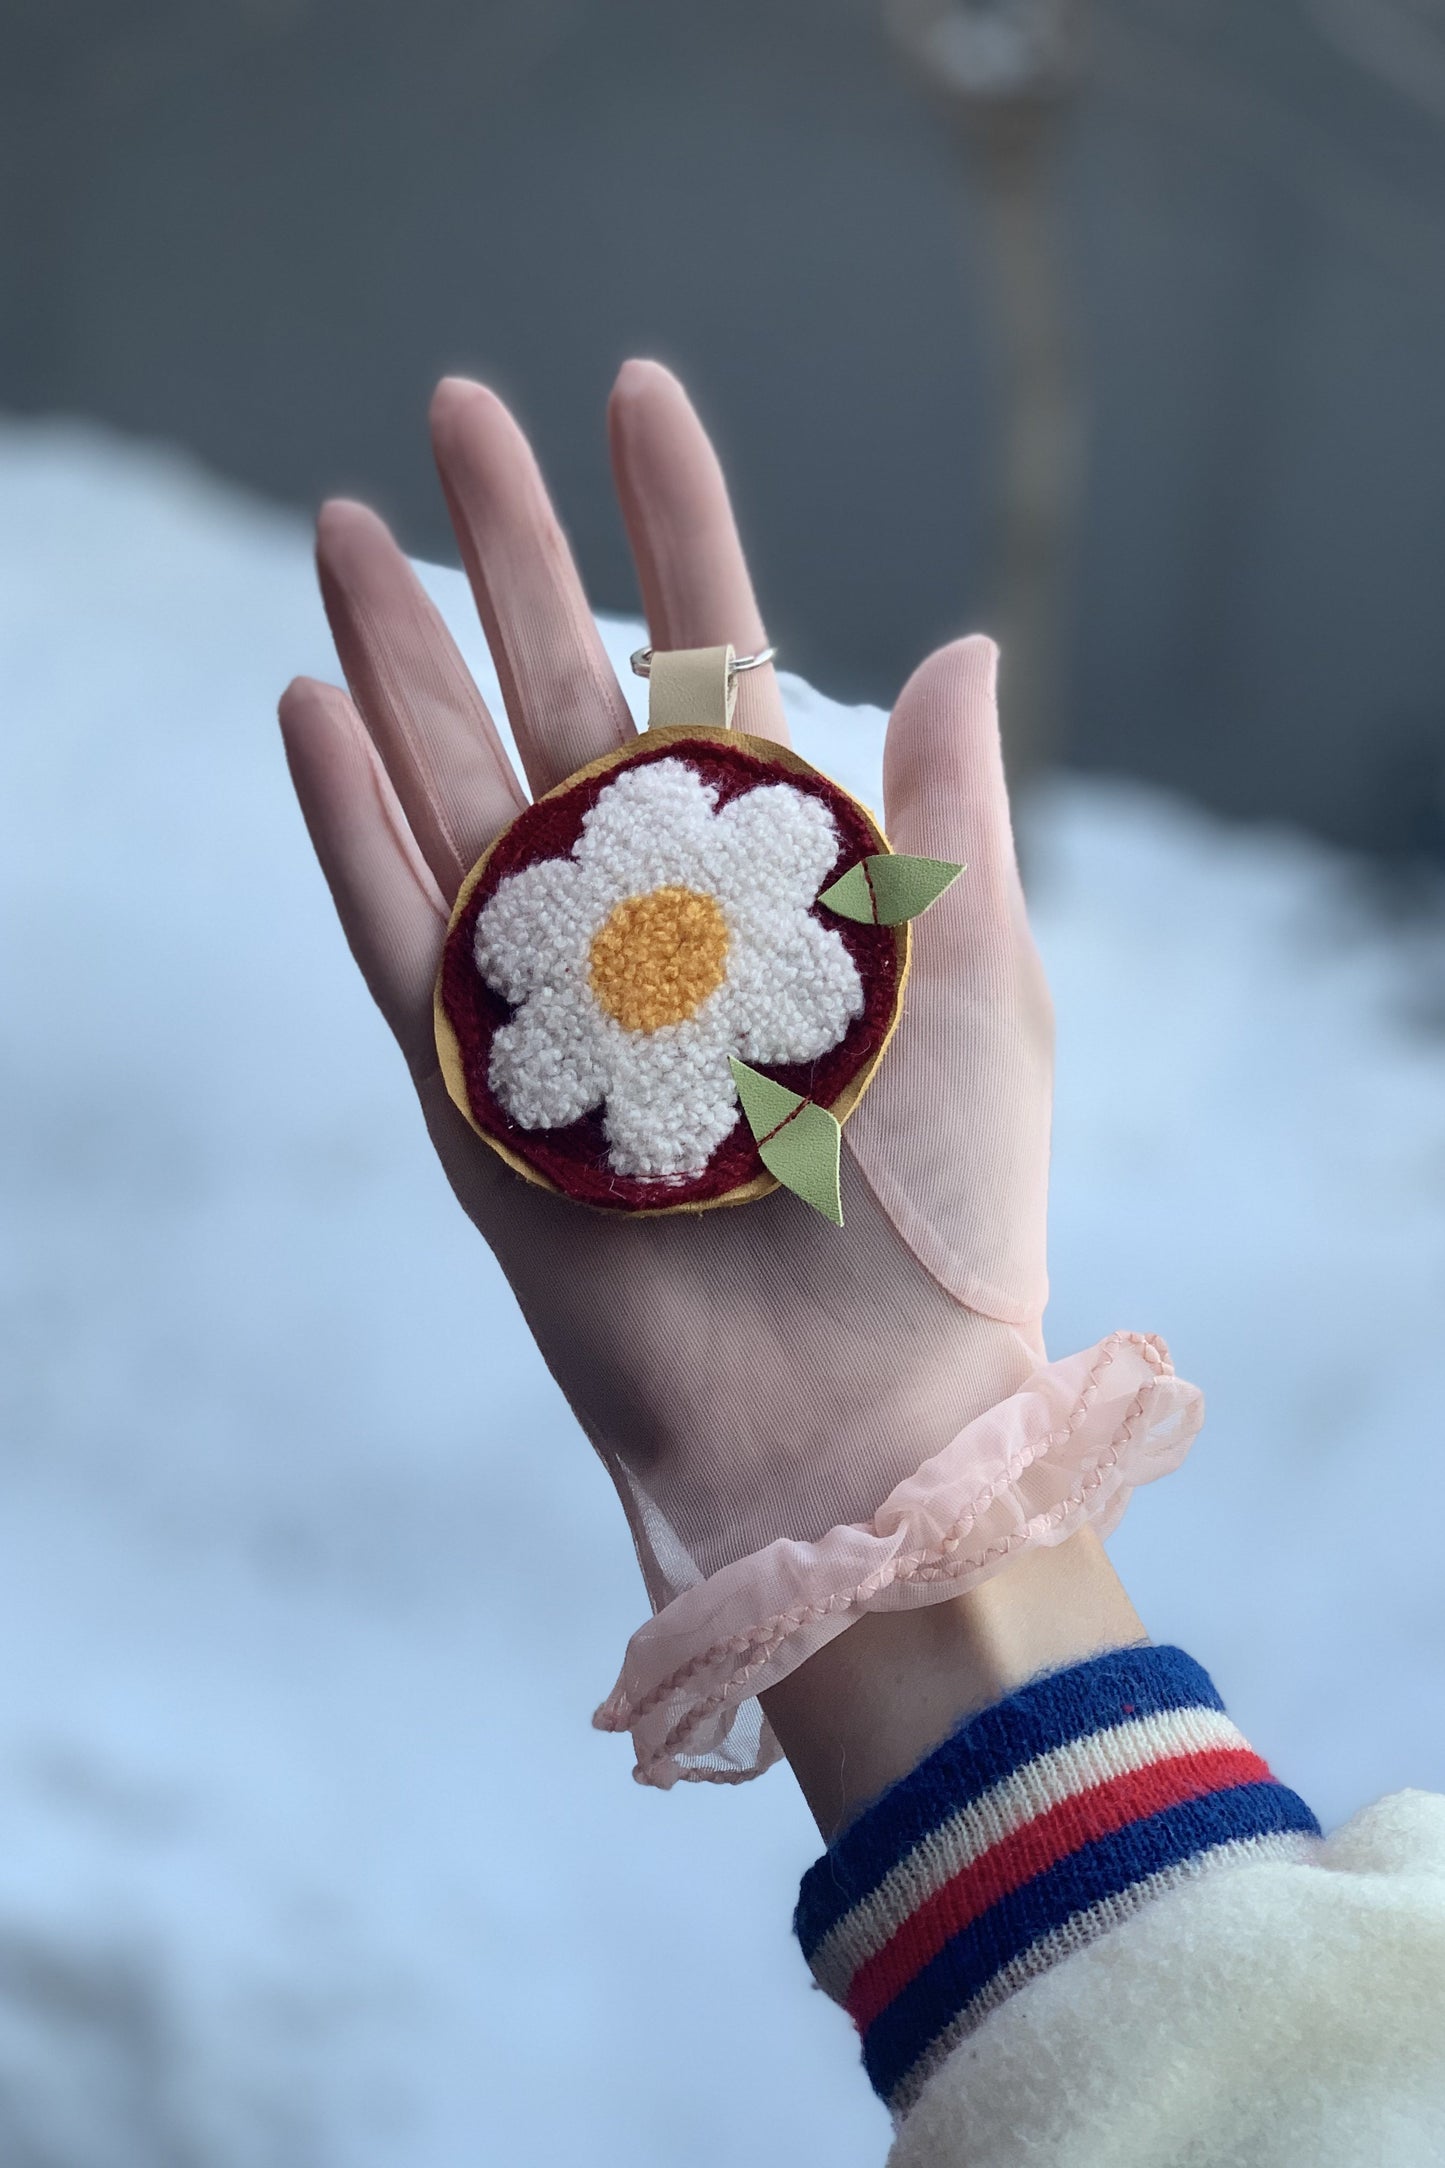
<box><xmin>607</xmin><ymin>362</ymin><xmax>789</xmax><ymax>744</ymax></box>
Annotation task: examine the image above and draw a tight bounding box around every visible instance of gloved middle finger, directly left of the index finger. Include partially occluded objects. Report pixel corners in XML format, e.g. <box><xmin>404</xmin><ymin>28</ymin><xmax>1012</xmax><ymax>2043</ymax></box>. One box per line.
<box><xmin>431</xmin><ymin>377</ymin><xmax>637</xmax><ymax>793</ymax></box>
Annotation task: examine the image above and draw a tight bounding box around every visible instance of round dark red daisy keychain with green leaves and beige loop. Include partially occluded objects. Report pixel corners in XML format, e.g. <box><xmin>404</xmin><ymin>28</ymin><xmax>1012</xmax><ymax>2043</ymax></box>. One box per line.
<box><xmin>435</xmin><ymin>646</ymin><xmax>964</xmax><ymax>1227</ymax></box>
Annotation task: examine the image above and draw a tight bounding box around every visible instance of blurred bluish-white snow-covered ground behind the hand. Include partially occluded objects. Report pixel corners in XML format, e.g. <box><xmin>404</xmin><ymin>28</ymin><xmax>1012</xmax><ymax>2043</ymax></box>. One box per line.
<box><xmin>0</xmin><ymin>414</ymin><xmax>1445</xmax><ymax>2168</ymax></box>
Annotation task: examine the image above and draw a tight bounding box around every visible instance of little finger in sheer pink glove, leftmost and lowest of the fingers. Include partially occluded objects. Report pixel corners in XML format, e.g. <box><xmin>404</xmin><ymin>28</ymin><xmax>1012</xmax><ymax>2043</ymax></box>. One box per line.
<box><xmin>279</xmin><ymin>679</ymin><xmax>446</xmax><ymax>1080</ymax></box>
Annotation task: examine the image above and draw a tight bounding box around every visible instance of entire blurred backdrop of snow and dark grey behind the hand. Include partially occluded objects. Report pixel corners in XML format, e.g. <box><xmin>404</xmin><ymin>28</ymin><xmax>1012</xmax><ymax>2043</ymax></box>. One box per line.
<box><xmin>0</xmin><ymin>0</ymin><xmax>1445</xmax><ymax>2168</ymax></box>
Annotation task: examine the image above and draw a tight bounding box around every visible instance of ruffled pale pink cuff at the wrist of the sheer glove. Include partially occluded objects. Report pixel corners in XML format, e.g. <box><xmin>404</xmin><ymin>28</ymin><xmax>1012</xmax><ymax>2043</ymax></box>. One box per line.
<box><xmin>594</xmin><ymin>1333</ymin><xmax>1205</xmax><ymax>1791</ymax></box>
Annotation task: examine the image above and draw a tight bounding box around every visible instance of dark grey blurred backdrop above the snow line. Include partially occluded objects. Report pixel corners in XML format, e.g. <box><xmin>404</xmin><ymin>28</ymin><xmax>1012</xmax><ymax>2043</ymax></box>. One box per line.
<box><xmin>0</xmin><ymin>0</ymin><xmax>1445</xmax><ymax>856</ymax></box>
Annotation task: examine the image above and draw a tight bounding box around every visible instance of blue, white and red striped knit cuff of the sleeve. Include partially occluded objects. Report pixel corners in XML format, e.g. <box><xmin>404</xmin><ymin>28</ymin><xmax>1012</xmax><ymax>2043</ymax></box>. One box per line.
<box><xmin>793</xmin><ymin>1648</ymin><xmax>1319</xmax><ymax>2116</ymax></box>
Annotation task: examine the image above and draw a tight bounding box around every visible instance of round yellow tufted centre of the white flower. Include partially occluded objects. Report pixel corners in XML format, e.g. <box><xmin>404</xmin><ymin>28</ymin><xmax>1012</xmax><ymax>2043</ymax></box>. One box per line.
<box><xmin>589</xmin><ymin>889</ymin><xmax>728</xmax><ymax>1032</ymax></box>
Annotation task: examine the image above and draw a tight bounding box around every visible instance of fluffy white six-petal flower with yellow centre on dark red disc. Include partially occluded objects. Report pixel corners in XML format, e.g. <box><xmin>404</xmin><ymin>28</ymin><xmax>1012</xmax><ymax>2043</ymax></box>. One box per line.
<box><xmin>474</xmin><ymin>759</ymin><xmax>862</xmax><ymax>1182</ymax></box>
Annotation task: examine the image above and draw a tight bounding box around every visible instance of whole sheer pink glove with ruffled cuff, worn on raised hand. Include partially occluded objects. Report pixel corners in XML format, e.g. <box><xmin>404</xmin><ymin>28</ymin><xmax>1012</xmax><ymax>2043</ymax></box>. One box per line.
<box><xmin>282</xmin><ymin>362</ymin><xmax>1200</xmax><ymax>1784</ymax></box>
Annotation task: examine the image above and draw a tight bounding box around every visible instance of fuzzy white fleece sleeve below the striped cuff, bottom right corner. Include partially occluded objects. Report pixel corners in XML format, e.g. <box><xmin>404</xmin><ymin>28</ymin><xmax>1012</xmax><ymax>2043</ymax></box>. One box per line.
<box><xmin>888</xmin><ymin>1791</ymin><xmax>1445</xmax><ymax>2168</ymax></box>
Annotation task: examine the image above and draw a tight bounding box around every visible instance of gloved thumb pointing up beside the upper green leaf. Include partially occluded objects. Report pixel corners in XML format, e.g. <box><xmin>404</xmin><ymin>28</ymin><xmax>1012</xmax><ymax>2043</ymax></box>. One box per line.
<box><xmin>884</xmin><ymin>633</ymin><xmax>1025</xmax><ymax>954</ymax></box>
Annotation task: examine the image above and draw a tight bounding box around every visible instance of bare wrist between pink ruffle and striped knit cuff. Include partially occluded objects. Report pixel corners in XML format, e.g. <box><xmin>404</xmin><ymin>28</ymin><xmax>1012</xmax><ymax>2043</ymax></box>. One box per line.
<box><xmin>763</xmin><ymin>1528</ymin><xmax>1146</xmax><ymax>1841</ymax></box>
